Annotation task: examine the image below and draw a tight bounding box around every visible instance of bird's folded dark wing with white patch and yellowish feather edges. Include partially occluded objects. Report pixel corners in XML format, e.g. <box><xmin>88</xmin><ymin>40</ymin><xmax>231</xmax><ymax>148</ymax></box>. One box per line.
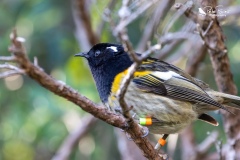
<box><xmin>133</xmin><ymin>70</ymin><xmax>228</xmax><ymax>111</ymax></box>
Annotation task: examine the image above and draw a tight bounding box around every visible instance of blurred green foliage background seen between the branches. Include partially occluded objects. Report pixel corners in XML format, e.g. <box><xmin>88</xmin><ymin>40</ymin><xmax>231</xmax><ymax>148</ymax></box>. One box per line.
<box><xmin>0</xmin><ymin>0</ymin><xmax>240</xmax><ymax>160</ymax></box>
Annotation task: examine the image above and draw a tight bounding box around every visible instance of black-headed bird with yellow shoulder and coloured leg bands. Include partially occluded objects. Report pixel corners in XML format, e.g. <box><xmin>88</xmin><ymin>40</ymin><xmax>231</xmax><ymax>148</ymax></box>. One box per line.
<box><xmin>76</xmin><ymin>43</ymin><xmax>240</xmax><ymax>148</ymax></box>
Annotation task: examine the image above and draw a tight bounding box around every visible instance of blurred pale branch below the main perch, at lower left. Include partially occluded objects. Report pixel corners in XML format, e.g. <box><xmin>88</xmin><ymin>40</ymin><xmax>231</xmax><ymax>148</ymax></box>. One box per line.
<box><xmin>52</xmin><ymin>115</ymin><xmax>97</xmax><ymax>160</ymax></box>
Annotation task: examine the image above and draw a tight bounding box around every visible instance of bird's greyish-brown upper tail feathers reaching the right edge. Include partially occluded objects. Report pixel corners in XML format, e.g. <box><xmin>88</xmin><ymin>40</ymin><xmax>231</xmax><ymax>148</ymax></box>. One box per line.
<box><xmin>207</xmin><ymin>91</ymin><xmax>240</xmax><ymax>109</ymax></box>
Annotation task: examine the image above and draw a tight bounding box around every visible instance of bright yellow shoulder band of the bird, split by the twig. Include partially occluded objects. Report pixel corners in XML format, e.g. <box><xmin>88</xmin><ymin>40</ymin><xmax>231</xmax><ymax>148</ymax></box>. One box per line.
<box><xmin>111</xmin><ymin>69</ymin><xmax>151</xmax><ymax>95</ymax></box>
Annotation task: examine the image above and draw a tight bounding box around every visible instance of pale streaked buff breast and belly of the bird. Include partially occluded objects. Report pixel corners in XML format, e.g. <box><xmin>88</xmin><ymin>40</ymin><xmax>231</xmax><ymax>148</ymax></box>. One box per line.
<box><xmin>109</xmin><ymin>83</ymin><xmax>198</xmax><ymax>134</ymax></box>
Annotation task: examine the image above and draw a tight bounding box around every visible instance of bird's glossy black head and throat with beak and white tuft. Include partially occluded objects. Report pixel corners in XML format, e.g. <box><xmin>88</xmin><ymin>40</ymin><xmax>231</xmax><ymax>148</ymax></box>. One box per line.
<box><xmin>75</xmin><ymin>43</ymin><xmax>132</xmax><ymax>103</ymax></box>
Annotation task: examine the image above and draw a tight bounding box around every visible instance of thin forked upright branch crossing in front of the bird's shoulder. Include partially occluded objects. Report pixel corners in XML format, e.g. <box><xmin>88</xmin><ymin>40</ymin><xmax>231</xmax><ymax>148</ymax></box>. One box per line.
<box><xmin>113</xmin><ymin>4</ymin><xmax>162</xmax><ymax>156</ymax></box>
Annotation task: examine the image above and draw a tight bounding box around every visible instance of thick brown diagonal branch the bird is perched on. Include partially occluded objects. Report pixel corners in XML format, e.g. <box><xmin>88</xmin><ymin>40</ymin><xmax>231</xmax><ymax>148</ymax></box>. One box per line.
<box><xmin>9</xmin><ymin>29</ymin><xmax>164</xmax><ymax>159</ymax></box>
